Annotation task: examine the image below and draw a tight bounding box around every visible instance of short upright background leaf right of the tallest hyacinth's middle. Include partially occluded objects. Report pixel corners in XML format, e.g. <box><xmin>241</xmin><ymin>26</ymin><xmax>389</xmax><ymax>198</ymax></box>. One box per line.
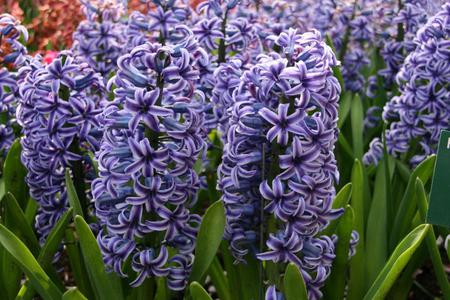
<box><xmin>350</xmin><ymin>95</ymin><xmax>364</xmax><ymax>159</ymax></box>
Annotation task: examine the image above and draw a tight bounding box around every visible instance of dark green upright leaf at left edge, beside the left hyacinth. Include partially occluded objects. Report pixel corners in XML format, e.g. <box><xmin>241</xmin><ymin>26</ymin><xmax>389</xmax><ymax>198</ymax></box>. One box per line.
<box><xmin>3</xmin><ymin>139</ymin><xmax>28</xmax><ymax>210</ymax></box>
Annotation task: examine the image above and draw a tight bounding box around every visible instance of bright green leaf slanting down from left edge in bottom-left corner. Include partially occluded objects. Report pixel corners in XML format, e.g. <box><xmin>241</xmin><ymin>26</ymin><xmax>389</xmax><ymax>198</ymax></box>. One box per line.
<box><xmin>0</xmin><ymin>224</ymin><xmax>62</xmax><ymax>300</ymax></box>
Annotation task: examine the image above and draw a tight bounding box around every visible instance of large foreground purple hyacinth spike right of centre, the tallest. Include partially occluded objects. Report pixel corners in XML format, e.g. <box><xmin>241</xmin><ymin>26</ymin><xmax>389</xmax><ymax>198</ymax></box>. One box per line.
<box><xmin>218</xmin><ymin>29</ymin><xmax>341</xmax><ymax>299</ymax></box>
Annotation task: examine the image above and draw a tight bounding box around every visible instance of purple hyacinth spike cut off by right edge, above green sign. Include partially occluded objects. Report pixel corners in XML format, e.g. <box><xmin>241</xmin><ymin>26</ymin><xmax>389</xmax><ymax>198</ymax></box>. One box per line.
<box><xmin>367</xmin><ymin>3</ymin><xmax>450</xmax><ymax>165</ymax></box>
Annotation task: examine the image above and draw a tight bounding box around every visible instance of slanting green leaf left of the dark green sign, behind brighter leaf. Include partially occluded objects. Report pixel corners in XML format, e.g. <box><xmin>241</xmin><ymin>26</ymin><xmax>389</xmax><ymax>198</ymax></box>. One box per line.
<box><xmin>389</xmin><ymin>155</ymin><xmax>436</xmax><ymax>249</ymax></box>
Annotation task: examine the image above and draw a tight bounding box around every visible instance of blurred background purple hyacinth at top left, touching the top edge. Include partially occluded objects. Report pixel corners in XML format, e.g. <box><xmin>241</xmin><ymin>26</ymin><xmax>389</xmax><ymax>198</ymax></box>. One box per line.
<box><xmin>73</xmin><ymin>0</ymin><xmax>126</xmax><ymax>80</ymax></box>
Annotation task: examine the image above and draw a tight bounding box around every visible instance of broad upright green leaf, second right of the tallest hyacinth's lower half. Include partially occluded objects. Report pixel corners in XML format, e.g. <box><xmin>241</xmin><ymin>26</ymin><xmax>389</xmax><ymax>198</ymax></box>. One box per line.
<box><xmin>366</xmin><ymin>160</ymin><xmax>388</xmax><ymax>285</ymax></box>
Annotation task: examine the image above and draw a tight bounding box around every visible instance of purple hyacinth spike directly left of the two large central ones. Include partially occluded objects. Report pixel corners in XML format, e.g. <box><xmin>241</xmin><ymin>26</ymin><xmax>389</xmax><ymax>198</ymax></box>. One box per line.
<box><xmin>17</xmin><ymin>52</ymin><xmax>102</xmax><ymax>239</ymax></box>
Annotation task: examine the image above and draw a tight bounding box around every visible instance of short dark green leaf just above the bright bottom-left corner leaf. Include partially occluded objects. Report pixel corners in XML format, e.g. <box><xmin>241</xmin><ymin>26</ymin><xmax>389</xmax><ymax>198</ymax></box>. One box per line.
<box><xmin>4</xmin><ymin>192</ymin><xmax>40</xmax><ymax>256</ymax></box>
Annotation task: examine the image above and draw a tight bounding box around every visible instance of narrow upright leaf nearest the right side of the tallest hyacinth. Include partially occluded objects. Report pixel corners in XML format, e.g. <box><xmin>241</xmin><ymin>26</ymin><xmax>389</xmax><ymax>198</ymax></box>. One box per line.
<box><xmin>348</xmin><ymin>159</ymin><xmax>366</xmax><ymax>300</ymax></box>
